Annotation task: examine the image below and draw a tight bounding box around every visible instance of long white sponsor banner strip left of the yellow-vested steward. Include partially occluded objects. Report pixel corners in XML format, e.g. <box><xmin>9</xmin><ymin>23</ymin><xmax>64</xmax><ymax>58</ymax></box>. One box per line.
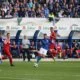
<box><xmin>0</xmin><ymin>18</ymin><xmax>53</xmax><ymax>31</ymax></box>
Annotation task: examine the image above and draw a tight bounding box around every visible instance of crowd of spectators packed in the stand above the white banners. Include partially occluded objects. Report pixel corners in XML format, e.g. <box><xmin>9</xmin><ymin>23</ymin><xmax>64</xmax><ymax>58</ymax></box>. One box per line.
<box><xmin>0</xmin><ymin>0</ymin><xmax>80</xmax><ymax>18</ymax></box>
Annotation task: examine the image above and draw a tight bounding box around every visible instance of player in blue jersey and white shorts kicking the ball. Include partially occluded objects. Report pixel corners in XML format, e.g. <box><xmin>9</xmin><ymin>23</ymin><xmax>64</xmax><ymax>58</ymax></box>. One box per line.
<box><xmin>34</xmin><ymin>34</ymin><xmax>50</xmax><ymax>67</ymax></box>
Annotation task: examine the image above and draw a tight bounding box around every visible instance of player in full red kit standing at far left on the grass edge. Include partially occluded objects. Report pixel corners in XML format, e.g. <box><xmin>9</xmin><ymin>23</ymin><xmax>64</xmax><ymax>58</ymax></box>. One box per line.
<box><xmin>3</xmin><ymin>33</ymin><xmax>14</xmax><ymax>66</ymax></box>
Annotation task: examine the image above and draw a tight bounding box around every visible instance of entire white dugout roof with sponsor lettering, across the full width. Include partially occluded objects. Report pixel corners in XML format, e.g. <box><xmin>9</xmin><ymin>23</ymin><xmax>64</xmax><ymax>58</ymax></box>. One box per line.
<box><xmin>0</xmin><ymin>18</ymin><xmax>80</xmax><ymax>36</ymax></box>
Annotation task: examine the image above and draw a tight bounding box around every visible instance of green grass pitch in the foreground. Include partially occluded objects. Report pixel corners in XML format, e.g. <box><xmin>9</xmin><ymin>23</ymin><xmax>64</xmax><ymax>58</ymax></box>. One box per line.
<box><xmin>0</xmin><ymin>62</ymin><xmax>80</xmax><ymax>80</ymax></box>
